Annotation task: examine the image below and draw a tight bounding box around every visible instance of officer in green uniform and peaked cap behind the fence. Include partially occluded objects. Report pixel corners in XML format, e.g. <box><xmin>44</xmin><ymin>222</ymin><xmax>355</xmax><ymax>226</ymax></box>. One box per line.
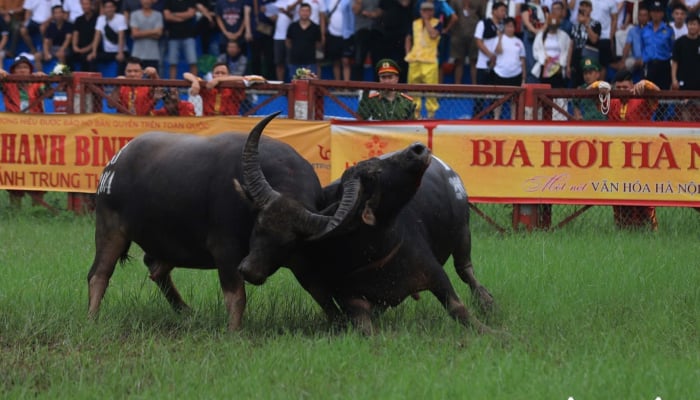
<box><xmin>357</xmin><ymin>58</ymin><xmax>416</xmax><ymax>121</ymax></box>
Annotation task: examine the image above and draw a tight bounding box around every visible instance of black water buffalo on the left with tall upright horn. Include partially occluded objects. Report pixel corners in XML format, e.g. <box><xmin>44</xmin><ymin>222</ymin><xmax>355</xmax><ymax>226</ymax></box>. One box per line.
<box><xmin>87</xmin><ymin>114</ymin><xmax>352</xmax><ymax>330</ymax></box>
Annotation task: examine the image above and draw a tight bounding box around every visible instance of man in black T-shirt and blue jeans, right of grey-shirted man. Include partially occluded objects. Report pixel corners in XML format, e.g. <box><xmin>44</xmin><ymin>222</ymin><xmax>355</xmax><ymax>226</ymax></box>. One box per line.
<box><xmin>163</xmin><ymin>0</ymin><xmax>197</xmax><ymax>79</ymax></box>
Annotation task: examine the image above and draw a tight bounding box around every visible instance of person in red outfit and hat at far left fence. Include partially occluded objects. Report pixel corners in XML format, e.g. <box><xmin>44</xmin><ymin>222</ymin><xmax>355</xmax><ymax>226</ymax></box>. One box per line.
<box><xmin>0</xmin><ymin>53</ymin><xmax>47</xmax><ymax>208</ymax></box>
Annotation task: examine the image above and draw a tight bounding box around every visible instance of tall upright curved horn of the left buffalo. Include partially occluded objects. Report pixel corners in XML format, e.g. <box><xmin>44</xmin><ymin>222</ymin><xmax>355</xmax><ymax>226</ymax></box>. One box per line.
<box><xmin>242</xmin><ymin>111</ymin><xmax>280</xmax><ymax>208</ymax></box>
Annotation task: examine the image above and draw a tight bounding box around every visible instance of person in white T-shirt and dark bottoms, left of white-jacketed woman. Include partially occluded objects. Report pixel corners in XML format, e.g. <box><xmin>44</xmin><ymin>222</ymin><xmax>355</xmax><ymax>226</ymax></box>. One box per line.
<box><xmin>493</xmin><ymin>17</ymin><xmax>526</xmax><ymax>119</ymax></box>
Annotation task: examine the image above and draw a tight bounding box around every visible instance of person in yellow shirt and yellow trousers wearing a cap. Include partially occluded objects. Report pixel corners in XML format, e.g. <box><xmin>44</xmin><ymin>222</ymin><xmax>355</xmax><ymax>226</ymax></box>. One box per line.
<box><xmin>404</xmin><ymin>1</ymin><xmax>442</xmax><ymax>119</ymax></box>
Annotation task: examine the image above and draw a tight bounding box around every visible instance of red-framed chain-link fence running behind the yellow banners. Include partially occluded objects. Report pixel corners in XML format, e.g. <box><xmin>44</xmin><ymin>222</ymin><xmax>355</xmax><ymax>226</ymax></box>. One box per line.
<box><xmin>0</xmin><ymin>74</ymin><xmax>700</xmax><ymax>232</ymax></box>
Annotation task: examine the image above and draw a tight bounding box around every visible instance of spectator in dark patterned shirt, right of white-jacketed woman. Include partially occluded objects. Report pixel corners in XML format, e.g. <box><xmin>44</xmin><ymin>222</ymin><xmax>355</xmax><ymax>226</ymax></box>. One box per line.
<box><xmin>567</xmin><ymin>0</ymin><xmax>602</xmax><ymax>87</ymax></box>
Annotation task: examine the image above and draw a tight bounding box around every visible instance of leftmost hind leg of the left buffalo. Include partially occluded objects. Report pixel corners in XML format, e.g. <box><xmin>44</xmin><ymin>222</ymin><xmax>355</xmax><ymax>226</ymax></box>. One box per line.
<box><xmin>87</xmin><ymin>218</ymin><xmax>131</xmax><ymax>318</ymax></box>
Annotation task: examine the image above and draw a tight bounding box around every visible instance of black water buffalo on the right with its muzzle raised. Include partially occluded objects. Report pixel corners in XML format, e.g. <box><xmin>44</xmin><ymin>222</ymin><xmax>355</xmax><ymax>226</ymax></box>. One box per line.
<box><xmin>239</xmin><ymin>122</ymin><xmax>493</xmax><ymax>333</ymax></box>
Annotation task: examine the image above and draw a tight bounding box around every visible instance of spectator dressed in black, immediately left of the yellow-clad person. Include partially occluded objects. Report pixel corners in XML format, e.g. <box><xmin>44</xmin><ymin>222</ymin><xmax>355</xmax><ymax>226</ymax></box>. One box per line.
<box><xmin>378</xmin><ymin>0</ymin><xmax>415</xmax><ymax>82</ymax></box>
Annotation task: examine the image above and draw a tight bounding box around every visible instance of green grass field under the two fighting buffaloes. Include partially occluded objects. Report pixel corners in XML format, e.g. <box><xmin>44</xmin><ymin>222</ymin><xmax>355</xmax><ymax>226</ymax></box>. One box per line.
<box><xmin>0</xmin><ymin>192</ymin><xmax>700</xmax><ymax>400</ymax></box>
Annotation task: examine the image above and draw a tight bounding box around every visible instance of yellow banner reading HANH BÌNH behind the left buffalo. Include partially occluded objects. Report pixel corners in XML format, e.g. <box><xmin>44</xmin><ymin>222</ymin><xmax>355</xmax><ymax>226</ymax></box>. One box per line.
<box><xmin>0</xmin><ymin>113</ymin><xmax>330</xmax><ymax>193</ymax></box>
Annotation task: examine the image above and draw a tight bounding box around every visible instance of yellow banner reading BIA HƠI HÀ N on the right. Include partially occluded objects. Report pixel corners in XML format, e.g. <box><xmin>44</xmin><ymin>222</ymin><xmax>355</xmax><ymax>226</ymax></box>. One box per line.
<box><xmin>331</xmin><ymin>121</ymin><xmax>700</xmax><ymax>206</ymax></box>
